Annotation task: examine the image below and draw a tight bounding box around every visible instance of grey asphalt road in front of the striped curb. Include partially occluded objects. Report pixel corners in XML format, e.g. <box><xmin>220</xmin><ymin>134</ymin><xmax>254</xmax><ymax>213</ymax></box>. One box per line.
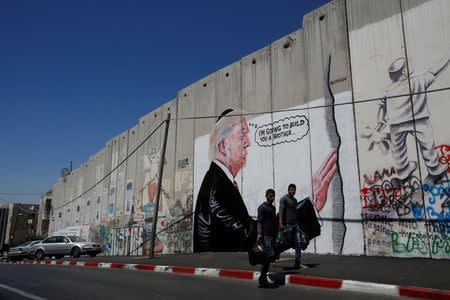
<box><xmin>0</xmin><ymin>264</ymin><xmax>410</xmax><ymax>300</ymax></box>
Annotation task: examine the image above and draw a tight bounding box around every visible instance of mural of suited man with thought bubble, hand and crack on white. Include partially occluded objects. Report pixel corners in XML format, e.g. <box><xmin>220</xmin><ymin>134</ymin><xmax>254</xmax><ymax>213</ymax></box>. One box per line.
<box><xmin>194</xmin><ymin>54</ymin><xmax>356</xmax><ymax>254</ymax></box>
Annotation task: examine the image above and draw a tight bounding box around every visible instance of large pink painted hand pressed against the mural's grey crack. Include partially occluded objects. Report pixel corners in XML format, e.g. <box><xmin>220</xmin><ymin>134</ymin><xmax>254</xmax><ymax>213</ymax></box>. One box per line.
<box><xmin>313</xmin><ymin>149</ymin><xmax>337</xmax><ymax>212</ymax></box>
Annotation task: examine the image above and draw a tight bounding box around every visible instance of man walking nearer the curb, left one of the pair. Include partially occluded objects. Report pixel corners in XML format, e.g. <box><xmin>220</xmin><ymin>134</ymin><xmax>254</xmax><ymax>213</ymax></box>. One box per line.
<box><xmin>257</xmin><ymin>189</ymin><xmax>277</xmax><ymax>288</ymax></box>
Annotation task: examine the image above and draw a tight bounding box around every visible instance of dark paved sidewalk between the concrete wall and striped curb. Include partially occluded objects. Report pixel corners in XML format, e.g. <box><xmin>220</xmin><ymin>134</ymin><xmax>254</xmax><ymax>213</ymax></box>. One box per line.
<box><xmin>42</xmin><ymin>252</ymin><xmax>450</xmax><ymax>290</ymax></box>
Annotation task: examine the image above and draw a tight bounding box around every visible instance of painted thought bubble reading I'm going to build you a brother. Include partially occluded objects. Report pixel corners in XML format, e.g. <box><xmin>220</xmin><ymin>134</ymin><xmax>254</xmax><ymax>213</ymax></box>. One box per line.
<box><xmin>255</xmin><ymin>115</ymin><xmax>309</xmax><ymax>147</ymax></box>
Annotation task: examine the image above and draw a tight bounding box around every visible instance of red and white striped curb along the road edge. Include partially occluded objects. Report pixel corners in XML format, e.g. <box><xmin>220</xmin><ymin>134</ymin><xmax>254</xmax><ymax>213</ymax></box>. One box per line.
<box><xmin>10</xmin><ymin>260</ymin><xmax>450</xmax><ymax>300</ymax></box>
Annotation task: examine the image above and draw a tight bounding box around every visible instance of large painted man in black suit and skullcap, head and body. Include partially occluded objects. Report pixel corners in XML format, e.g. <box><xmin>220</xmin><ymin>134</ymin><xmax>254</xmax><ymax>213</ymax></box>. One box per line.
<box><xmin>194</xmin><ymin>109</ymin><xmax>256</xmax><ymax>252</ymax></box>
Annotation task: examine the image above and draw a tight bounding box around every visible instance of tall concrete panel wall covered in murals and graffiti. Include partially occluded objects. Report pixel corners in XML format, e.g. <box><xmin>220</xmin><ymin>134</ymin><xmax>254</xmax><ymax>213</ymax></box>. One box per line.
<box><xmin>50</xmin><ymin>0</ymin><xmax>450</xmax><ymax>259</ymax></box>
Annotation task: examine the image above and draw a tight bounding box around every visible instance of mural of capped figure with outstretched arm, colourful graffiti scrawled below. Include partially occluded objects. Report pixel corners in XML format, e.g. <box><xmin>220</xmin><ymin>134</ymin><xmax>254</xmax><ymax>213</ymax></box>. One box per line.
<box><xmin>360</xmin><ymin>49</ymin><xmax>450</xmax><ymax>257</ymax></box>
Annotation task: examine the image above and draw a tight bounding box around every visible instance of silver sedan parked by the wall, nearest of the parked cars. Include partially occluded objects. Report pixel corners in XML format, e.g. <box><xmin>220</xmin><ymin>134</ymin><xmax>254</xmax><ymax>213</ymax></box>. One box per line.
<box><xmin>30</xmin><ymin>235</ymin><xmax>102</xmax><ymax>260</ymax></box>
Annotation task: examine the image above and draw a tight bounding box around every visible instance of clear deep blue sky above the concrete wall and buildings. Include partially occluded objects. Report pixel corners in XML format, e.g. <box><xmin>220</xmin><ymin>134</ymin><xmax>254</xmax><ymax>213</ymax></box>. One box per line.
<box><xmin>0</xmin><ymin>0</ymin><xmax>328</xmax><ymax>203</ymax></box>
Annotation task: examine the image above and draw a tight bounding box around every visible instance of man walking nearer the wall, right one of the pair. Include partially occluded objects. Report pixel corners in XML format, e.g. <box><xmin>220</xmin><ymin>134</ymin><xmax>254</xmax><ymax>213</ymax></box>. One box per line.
<box><xmin>279</xmin><ymin>183</ymin><xmax>303</xmax><ymax>270</ymax></box>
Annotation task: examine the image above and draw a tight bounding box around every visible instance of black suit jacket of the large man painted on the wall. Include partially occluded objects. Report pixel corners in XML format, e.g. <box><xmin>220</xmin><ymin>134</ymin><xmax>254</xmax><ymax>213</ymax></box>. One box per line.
<box><xmin>194</xmin><ymin>162</ymin><xmax>256</xmax><ymax>252</ymax></box>
